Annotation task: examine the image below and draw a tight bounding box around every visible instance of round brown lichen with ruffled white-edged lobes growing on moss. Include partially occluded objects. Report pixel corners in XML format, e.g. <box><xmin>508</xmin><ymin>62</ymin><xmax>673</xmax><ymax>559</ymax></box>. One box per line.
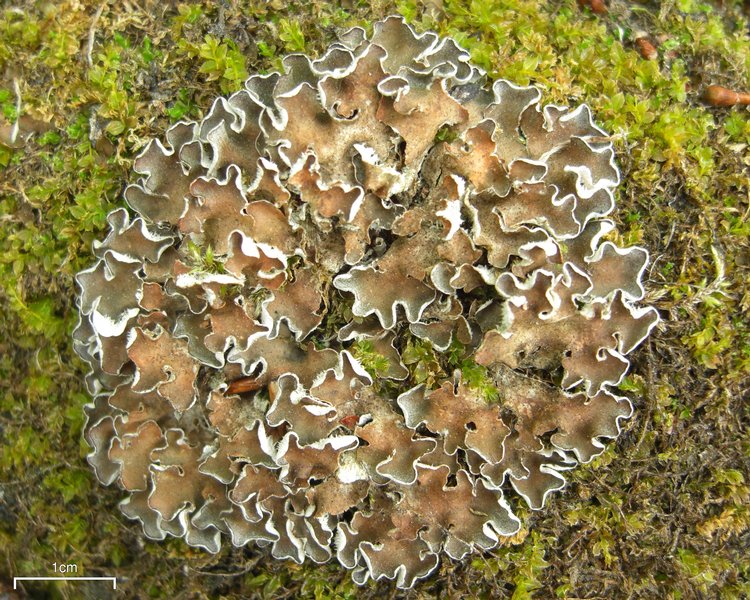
<box><xmin>74</xmin><ymin>17</ymin><xmax>658</xmax><ymax>587</ymax></box>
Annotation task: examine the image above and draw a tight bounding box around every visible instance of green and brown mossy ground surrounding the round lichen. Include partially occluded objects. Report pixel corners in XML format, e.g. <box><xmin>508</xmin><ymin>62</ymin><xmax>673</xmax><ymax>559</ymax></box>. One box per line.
<box><xmin>0</xmin><ymin>0</ymin><xmax>750</xmax><ymax>599</ymax></box>
